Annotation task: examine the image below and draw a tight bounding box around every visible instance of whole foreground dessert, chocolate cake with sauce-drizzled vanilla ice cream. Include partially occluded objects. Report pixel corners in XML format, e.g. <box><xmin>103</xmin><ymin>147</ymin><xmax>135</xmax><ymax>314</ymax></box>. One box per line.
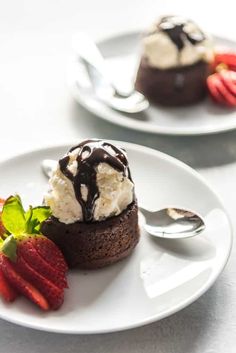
<box><xmin>42</xmin><ymin>139</ymin><xmax>139</xmax><ymax>268</ymax></box>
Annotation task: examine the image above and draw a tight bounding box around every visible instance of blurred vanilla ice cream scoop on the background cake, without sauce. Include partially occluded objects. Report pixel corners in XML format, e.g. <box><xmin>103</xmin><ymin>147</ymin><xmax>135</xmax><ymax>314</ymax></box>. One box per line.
<box><xmin>143</xmin><ymin>18</ymin><xmax>214</xmax><ymax>70</ymax></box>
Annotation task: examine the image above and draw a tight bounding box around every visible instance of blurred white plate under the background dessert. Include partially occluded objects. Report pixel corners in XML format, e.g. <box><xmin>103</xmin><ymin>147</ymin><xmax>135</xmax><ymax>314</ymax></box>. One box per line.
<box><xmin>68</xmin><ymin>32</ymin><xmax>236</xmax><ymax>135</ymax></box>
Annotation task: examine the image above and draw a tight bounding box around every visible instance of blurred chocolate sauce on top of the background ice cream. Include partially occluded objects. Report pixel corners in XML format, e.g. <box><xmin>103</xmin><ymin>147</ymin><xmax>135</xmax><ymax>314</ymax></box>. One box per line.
<box><xmin>151</xmin><ymin>16</ymin><xmax>206</xmax><ymax>51</ymax></box>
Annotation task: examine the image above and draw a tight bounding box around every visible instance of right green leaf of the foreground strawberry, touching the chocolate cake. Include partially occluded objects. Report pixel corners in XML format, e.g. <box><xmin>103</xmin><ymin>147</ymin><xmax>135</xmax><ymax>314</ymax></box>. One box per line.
<box><xmin>25</xmin><ymin>206</ymin><xmax>51</xmax><ymax>234</ymax></box>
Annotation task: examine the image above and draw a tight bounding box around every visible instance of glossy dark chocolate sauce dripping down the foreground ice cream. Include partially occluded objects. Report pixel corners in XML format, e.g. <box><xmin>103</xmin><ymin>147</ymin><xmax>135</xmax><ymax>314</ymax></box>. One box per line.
<box><xmin>59</xmin><ymin>139</ymin><xmax>132</xmax><ymax>222</ymax></box>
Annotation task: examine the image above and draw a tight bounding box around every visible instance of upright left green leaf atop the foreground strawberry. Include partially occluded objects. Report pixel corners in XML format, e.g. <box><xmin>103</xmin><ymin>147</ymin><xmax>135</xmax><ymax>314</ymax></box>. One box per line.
<box><xmin>1</xmin><ymin>195</ymin><xmax>26</xmax><ymax>235</ymax></box>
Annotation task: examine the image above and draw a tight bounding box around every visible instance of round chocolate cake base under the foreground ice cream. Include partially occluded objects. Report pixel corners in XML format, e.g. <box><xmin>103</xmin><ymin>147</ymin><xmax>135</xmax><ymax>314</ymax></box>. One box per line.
<box><xmin>41</xmin><ymin>201</ymin><xmax>139</xmax><ymax>269</ymax></box>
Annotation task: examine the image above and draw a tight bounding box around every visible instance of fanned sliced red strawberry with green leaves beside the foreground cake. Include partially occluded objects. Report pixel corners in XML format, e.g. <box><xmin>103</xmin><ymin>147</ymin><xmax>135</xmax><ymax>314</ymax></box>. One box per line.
<box><xmin>0</xmin><ymin>195</ymin><xmax>68</xmax><ymax>310</ymax></box>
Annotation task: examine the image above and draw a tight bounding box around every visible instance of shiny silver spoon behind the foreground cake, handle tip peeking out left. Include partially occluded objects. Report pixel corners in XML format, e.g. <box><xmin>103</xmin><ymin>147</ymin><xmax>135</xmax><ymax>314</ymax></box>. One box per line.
<box><xmin>41</xmin><ymin>159</ymin><xmax>205</xmax><ymax>239</ymax></box>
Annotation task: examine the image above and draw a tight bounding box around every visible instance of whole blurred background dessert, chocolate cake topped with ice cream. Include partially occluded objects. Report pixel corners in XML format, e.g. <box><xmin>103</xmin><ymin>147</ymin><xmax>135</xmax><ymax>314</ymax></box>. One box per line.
<box><xmin>135</xmin><ymin>16</ymin><xmax>214</xmax><ymax>105</ymax></box>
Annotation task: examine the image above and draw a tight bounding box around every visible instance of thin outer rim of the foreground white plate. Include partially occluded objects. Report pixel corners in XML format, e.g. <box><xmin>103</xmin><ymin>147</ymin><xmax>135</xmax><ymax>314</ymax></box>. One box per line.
<box><xmin>0</xmin><ymin>139</ymin><xmax>234</xmax><ymax>335</ymax></box>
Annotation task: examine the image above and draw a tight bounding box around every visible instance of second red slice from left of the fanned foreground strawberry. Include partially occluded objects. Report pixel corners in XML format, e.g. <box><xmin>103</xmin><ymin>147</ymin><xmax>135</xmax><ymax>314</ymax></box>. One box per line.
<box><xmin>0</xmin><ymin>254</ymin><xmax>49</xmax><ymax>310</ymax></box>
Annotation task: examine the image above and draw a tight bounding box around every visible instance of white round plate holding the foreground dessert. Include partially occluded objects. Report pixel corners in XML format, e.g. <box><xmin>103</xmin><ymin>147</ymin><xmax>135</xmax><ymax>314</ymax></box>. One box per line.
<box><xmin>0</xmin><ymin>142</ymin><xmax>232</xmax><ymax>334</ymax></box>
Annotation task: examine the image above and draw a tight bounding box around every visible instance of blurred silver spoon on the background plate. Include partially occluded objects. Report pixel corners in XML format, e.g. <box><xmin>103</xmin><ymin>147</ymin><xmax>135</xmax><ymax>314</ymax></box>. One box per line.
<box><xmin>73</xmin><ymin>33</ymin><xmax>149</xmax><ymax>113</ymax></box>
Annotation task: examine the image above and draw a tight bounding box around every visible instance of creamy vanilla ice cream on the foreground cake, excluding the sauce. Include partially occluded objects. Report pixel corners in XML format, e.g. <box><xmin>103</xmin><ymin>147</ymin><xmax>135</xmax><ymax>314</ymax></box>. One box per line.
<box><xmin>44</xmin><ymin>146</ymin><xmax>134</xmax><ymax>224</ymax></box>
